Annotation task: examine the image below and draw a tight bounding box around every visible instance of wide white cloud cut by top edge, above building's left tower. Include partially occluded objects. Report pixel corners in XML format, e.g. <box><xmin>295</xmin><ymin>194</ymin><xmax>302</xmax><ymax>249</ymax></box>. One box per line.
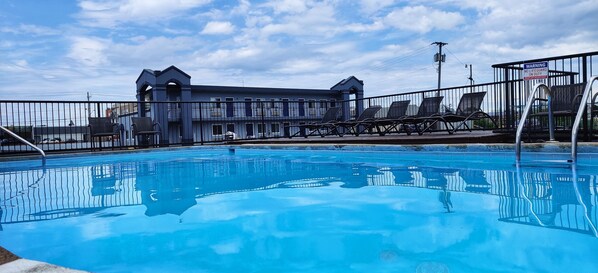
<box><xmin>79</xmin><ymin>0</ymin><xmax>211</xmax><ymax>28</ymax></box>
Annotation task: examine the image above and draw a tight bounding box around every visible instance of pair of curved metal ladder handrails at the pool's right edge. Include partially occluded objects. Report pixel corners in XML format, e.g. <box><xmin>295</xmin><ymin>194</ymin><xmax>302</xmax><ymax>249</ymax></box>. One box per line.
<box><xmin>515</xmin><ymin>76</ymin><xmax>598</xmax><ymax>162</ymax></box>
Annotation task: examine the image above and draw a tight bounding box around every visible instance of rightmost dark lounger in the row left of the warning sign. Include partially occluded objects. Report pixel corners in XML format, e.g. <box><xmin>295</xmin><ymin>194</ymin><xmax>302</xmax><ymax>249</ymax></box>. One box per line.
<box><xmin>430</xmin><ymin>92</ymin><xmax>497</xmax><ymax>134</ymax></box>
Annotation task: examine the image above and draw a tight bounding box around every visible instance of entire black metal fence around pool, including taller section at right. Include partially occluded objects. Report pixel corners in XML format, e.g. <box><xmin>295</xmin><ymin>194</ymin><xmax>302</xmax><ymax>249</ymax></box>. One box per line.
<box><xmin>0</xmin><ymin>52</ymin><xmax>598</xmax><ymax>155</ymax></box>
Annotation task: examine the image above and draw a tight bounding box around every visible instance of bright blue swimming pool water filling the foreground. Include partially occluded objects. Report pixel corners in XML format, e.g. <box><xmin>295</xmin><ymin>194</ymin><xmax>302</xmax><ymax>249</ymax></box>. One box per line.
<box><xmin>0</xmin><ymin>149</ymin><xmax>598</xmax><ymax>273</ymax></box>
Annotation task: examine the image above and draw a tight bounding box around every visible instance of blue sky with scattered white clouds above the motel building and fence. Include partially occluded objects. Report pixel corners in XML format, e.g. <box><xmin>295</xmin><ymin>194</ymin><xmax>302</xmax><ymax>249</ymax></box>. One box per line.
<box><xmin>0</xmin><ymin>0</ymin><xmax>598</xmax><ymax>101</ymax></box>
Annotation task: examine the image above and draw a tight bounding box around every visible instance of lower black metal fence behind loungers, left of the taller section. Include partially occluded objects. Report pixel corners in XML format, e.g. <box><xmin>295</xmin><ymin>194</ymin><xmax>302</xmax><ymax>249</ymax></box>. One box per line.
<box><xmin>0</xmin><ymin>90</ymin><xmax>503</xmax><ymax>154</ymax></box>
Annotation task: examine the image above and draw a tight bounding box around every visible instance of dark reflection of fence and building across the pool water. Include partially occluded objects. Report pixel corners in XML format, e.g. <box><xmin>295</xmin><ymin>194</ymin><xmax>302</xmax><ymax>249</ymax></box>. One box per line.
<box><xmin>0</xmin><ymin>155</ymin><xmax>598</xmax><ymax>236</ymax></box>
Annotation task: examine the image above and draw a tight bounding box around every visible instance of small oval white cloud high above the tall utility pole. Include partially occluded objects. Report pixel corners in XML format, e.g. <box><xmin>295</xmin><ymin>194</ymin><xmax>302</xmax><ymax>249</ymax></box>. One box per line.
<box><xmin>384</xmin><ymin>6</ymin><xmax>465</xmax><ymax>33</ymax></box>
